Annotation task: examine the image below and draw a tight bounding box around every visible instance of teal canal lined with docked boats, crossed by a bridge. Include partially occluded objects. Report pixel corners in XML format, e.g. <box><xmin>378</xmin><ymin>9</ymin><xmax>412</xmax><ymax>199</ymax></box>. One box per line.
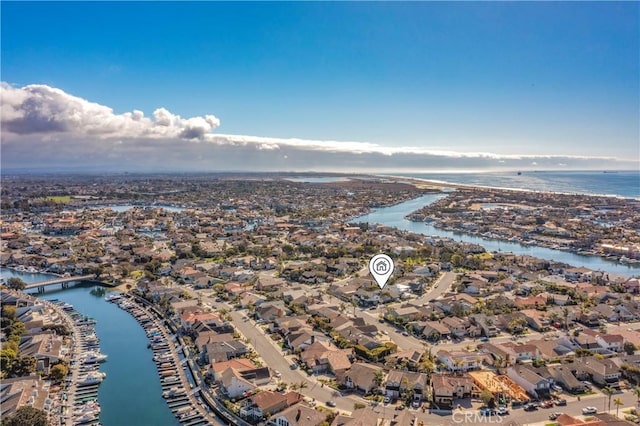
<box><xmin>0</xmin><ymin>268</ymin><xmax>179</xmax><ymax>426</ymax></box>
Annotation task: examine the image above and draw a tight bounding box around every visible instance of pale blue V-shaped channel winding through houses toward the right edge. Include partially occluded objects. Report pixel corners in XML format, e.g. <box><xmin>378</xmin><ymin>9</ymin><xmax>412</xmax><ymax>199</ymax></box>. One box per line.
<box><xmin>351</xmin><ymin>194</ymin><xmax>640</xmax><ymax>276</ymax></box>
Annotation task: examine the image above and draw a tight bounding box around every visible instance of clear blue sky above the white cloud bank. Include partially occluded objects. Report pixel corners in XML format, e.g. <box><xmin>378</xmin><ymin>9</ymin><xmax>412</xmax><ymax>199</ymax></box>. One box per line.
<box><xmin>1</xmin><ymin>1</ymin><xmax>640</xmax><ymax>171</ymax></box>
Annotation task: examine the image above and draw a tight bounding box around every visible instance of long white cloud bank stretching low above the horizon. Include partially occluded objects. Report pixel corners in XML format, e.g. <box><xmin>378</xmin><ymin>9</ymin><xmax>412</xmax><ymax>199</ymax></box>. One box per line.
<box><xmin>0</xmin><ymin>83</ymin><xmax>638</xmax><ymax>172</ymax></box>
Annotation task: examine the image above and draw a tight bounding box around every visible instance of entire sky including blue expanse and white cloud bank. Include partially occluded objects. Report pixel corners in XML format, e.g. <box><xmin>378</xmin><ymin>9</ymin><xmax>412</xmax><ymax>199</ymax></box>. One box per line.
<box><xmin>0</xmin><ymin>1</ymin><xmax>640</xmax><ymax>173</ymax></box>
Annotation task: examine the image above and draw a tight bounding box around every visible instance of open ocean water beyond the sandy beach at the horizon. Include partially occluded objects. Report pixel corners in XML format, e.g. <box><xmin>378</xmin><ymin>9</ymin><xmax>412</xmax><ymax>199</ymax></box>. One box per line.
<box><xmin>398</xmin><ymin>170</ymin><xmax>640</xmax><ymax>199</ymax></box>
